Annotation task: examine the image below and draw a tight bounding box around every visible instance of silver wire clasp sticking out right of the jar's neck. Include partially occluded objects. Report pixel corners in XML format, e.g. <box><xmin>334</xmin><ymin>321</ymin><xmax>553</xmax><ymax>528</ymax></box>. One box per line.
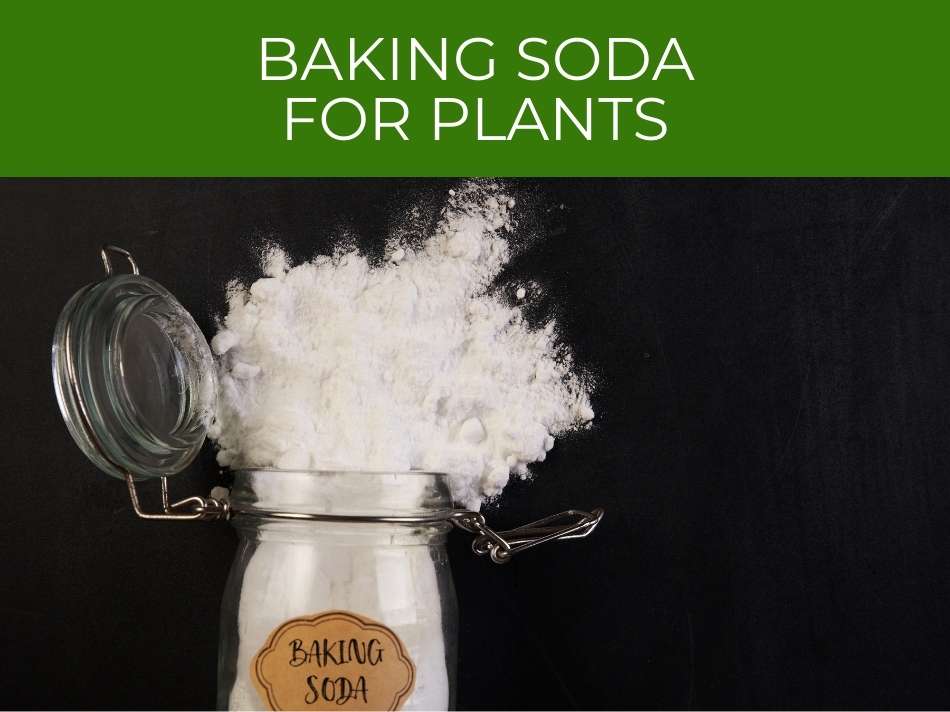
<box><xmin>450</xmin><ymin>507</ymin><xmax>604</xmax><ymax>564</ymax></box>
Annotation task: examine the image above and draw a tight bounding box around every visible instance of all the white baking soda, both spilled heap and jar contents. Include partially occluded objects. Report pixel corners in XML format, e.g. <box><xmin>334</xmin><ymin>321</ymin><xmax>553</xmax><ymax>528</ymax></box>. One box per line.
<box><xmin>211</xmin><ymin>185</ymin><xmax>593</xmax><ymax>710</ymax></box>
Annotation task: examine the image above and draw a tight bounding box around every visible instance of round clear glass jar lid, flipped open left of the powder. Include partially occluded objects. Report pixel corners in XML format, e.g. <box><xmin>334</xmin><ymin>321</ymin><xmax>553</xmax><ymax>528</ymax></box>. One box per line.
<box><xmin>53</xmin><ymin>246</ymin><xmax>217</xmax><ymax>479</ymax></box>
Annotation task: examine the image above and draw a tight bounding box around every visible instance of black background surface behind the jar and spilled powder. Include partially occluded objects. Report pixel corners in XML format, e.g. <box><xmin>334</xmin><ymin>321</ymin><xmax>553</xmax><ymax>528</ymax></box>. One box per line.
<box><xmin>0</xmin><ymin>180</ymin><xmax>950</xmax><ymax>708</ymax></box>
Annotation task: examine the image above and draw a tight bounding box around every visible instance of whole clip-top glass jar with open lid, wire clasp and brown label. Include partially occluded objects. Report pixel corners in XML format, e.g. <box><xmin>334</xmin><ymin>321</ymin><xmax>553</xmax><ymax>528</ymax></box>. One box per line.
<box><xmin>52</xmin><ymin>245</ymin><xmax>603</xmax><ymax>710</ymax></box>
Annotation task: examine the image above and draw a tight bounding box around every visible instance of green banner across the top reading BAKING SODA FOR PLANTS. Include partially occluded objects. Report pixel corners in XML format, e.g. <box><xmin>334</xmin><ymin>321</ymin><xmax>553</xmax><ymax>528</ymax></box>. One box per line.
<box><xmin>0</xmin><ymin>0</ymin><xmax>950</xmax><ymax>176</ymax></box>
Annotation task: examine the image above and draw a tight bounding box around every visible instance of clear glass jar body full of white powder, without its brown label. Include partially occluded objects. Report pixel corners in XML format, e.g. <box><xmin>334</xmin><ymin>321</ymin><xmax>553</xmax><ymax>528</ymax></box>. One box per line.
<box><xmin>218</xmin><ymin>471</ymin><xmax>458</xmax><ymax>710</ymax></box>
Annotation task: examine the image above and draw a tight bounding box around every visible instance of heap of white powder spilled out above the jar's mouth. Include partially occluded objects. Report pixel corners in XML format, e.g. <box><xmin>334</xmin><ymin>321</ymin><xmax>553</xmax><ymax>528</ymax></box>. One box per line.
<box><xmin>211</xmin><ymin>185</ymin><xmax>594</xmax><ymax>510</ymax></box>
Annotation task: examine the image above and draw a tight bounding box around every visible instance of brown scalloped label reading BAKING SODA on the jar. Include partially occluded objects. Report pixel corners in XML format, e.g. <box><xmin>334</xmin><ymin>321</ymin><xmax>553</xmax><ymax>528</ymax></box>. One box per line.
<box><xmin>251</xmin><ymin>611</ymin><xmax>416</xmax><ymax>710</ymax></box>
